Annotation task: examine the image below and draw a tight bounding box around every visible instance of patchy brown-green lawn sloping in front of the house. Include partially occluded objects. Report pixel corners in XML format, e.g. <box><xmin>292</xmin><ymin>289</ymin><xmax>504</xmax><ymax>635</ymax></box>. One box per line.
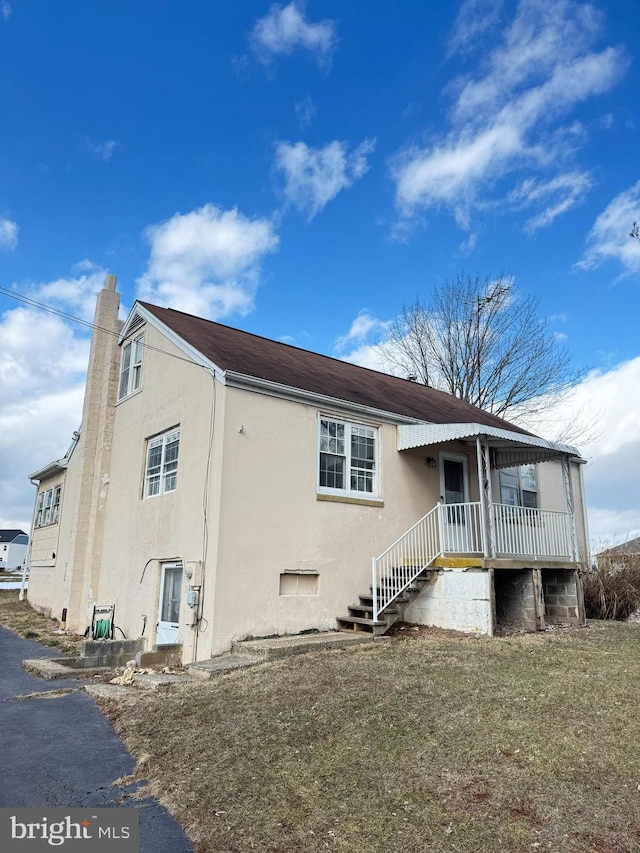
<box><xmin>0</xmin><ymin>592</ymin><xmax>640</xmax><ymax>853</ymax></box>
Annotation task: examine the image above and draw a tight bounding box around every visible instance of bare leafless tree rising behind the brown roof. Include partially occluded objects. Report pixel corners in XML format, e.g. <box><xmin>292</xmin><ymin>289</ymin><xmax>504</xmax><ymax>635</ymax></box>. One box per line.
<box><xmin>381</xmin><ymin>275</ymin><xmax>584</xmax><ymax>417</ymax></box>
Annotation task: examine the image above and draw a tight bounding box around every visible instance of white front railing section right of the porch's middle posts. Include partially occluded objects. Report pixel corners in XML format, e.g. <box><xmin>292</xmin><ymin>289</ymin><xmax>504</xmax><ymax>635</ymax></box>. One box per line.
<box><xmin>493</xmin><ymin>504</ymin><xmax>573</xmax><ymax>560</ymax></box>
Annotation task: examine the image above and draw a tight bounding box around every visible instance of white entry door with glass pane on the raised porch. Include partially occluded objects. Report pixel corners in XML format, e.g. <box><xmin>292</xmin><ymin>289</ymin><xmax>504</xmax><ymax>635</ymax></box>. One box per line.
<box><xmin>440</xmin><ymin>453</ymin><xmax>473</xmax><ymax>554</ymax></box>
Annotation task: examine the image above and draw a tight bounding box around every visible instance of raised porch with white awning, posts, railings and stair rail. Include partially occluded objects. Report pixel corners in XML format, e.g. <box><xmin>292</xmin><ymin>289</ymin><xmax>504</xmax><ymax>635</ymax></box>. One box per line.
<box><xmin>372</xmin><ymin>424</ymin><xmax>580</xmax><ymax>619</ymax></box>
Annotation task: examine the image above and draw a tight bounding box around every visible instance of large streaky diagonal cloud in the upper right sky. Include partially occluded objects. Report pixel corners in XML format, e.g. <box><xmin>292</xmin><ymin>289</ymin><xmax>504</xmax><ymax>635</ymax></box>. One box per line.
<box><xmin>390</xmin><ymin>0</ymin><xmax>628</xmax><ymax>231</ymax></box>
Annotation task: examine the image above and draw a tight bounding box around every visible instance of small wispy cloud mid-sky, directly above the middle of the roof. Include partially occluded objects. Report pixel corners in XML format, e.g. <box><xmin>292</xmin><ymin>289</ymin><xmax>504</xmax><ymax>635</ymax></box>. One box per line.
<box><xmin>276</xmin><ymin>139</ymin><xmax>376</xmax><ymax>221</ymax></box>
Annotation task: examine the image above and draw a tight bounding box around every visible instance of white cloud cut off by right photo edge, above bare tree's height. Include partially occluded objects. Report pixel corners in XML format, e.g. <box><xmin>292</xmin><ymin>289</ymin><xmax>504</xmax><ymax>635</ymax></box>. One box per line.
<box><xmin>578</xmin><ymin>181</ymin><xmax>640</xmax><ymax>273</ymax></box>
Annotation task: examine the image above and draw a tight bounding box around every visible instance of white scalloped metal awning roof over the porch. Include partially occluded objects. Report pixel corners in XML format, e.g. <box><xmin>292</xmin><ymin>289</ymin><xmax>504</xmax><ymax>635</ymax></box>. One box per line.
<box><xmin>398</xmin><ymin>423</ymin><xmax>580</xmax><ymax>468</ymax></box>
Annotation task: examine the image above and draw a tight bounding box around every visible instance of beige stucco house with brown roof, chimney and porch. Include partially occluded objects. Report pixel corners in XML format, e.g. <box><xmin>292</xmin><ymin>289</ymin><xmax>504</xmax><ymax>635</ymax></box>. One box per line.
<box><xmin>29</xmin><ymin>276</ymin><xmax>587</xmax><ymax>662</ymax></box>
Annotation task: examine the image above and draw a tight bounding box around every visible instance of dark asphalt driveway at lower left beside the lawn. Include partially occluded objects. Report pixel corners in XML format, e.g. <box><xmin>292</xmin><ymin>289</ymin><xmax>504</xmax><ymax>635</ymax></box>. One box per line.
<box><xmin>0</xmin><ymin>627</ymin><xmax>193</xmax><ymax>853</ymax></box>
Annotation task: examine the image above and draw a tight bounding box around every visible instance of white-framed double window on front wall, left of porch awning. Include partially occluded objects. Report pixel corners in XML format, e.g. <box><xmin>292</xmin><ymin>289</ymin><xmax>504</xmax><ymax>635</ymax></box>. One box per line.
<box><xmin>318</xmin><ymin>417</ymin><xmax>379</xmax><ymax>497</ymax></box>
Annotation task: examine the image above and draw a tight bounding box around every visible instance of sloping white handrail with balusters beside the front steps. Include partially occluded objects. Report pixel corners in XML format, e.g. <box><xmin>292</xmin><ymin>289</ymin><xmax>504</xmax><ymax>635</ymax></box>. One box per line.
<box><xmin>372</xmin><ymin>506</ymin><xmax>440</xmax><ymax>619</ymax></box>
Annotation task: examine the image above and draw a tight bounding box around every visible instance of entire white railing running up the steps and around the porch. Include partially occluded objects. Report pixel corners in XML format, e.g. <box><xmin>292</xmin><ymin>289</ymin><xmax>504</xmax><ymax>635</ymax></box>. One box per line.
<box><xmin>372</xmin><ymin>503</ymin><xmax>573</xmax><ymax>619</ymax></box>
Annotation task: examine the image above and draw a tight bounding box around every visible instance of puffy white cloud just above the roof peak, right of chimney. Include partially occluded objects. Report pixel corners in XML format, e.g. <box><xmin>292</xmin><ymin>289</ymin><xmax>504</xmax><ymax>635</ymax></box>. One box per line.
<box><xmin>137</xmin><ymin>204</ymin><xmax>278</xmax><ymax>319</ymax></box>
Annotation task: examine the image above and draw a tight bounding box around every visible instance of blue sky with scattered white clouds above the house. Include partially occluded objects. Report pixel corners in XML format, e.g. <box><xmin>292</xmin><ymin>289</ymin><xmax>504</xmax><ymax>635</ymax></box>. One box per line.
<box><xmin>0</xmin><ymin>0</ymin><xmax>640</xmax><ymax>540</ymax></box>
